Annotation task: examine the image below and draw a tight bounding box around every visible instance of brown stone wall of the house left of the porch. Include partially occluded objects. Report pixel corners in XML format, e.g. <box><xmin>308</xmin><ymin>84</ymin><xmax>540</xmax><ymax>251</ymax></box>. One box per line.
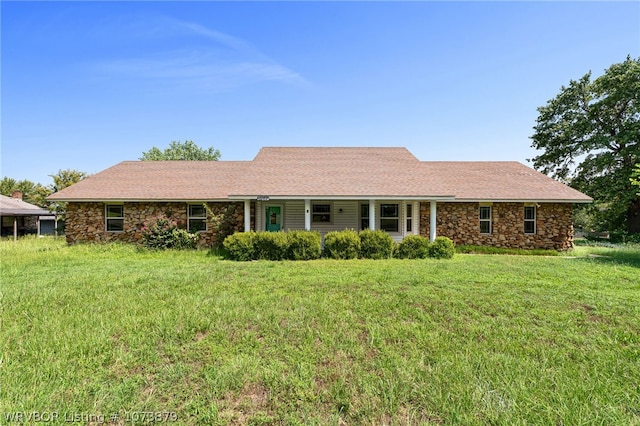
<box><xmin>65</xmin><ymin>202</ymin><xmax>255</xmax><ymax>246</ymax></box>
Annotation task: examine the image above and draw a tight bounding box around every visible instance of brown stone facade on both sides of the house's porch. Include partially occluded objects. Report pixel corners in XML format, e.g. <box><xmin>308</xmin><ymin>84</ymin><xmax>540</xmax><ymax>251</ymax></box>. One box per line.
<box><xmin>66</xmin><ymin>202</ymin><xmax>573</xmax><ymax>250</ymax></box>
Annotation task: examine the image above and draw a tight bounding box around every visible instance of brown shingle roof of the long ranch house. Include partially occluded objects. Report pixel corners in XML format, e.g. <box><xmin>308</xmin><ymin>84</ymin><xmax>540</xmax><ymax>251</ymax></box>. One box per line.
<box><xmin>49</xmin><ymin>148</ymin><xmax>591</xmax><ymax>202</ymax></box>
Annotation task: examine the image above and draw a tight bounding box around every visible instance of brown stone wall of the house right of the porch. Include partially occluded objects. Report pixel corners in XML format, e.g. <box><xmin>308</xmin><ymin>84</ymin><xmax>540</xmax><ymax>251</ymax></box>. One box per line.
<box><xmin>420</xmin><ymin>203</ymin><xmax>573</xmax><ymax>250</ymax></box>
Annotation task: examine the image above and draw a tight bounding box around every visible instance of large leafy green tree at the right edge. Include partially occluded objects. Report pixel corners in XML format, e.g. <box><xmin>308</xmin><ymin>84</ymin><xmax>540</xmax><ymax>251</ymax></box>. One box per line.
<box><xmin>531</xmin><ymin>57</ymin><xmax>640</xmax><ymax>233</ymax></box>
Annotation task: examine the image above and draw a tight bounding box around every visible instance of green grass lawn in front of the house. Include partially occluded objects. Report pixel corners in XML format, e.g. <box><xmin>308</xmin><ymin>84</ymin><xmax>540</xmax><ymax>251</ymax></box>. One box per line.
<box><xmin>0</xmin><ymin>238</ymin><xmax>640</xmax><ymax>425</ymax></box>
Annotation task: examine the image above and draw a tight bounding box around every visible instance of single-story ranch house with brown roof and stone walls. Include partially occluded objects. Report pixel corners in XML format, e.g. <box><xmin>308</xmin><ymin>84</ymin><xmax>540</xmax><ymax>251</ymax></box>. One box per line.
<box><xmin>49</xmin><ymin>147</ymin><xmax>592</xmax><ymax>250</ymax></box>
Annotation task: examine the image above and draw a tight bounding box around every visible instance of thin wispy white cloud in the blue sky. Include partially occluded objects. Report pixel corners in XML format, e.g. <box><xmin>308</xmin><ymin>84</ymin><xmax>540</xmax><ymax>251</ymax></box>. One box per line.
<box><xmin>87</xmin><ymin>18</ymin><xmax>311</xmax><ymax>92</ymax></box>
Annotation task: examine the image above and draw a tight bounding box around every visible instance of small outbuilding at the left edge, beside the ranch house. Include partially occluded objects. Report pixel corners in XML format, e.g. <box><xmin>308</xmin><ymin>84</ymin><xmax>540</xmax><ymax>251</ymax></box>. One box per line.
<box><xmin>0</xmin><ymin>191</ymin><xmax>56</xmax><ymax>239</ymax></box>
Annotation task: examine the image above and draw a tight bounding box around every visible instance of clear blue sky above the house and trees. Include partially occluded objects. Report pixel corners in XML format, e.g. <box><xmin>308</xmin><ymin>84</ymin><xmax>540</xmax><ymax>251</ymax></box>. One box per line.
<box><xmin>0</xmin><ymin>1</ymin><xmax>640</xmax><ymax>184</ymax></box>
